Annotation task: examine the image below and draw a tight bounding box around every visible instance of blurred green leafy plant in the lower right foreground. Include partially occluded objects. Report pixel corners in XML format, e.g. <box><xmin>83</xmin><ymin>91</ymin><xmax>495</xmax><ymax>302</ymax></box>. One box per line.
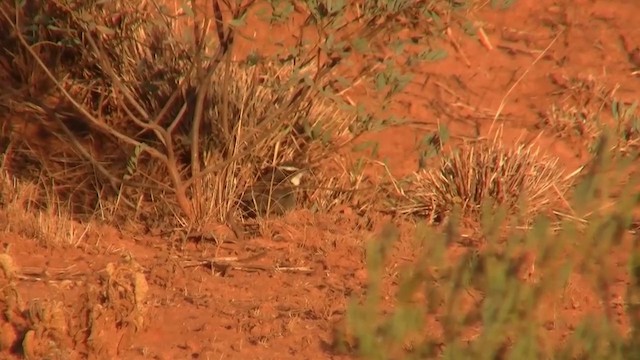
<box><xmin>337</xmin><ymin>136</ymin><xmax>640</xmax><ymax>359</ymax></box>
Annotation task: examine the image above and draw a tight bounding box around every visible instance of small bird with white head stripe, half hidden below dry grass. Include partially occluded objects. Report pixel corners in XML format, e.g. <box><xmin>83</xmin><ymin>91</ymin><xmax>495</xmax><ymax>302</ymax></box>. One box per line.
<box><xmin>241</xmin><ymin>164</ymin><xmax>307</xmax><ymax>217</ymax></box>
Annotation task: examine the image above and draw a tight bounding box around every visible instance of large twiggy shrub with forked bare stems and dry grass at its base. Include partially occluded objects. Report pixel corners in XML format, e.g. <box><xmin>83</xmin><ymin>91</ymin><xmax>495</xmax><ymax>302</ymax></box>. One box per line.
<box><xmin>0</xmin><ymin>0</ymin><xmax>449</xmax><ymax>225</ymax></box>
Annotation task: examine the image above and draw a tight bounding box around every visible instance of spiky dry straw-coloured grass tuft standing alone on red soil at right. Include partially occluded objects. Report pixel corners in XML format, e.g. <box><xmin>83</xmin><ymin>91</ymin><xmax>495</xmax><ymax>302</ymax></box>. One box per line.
<box><xmin>399</xmin><ymin>141</ymin><xmax>573</xmax><ymax>225</ymax></box>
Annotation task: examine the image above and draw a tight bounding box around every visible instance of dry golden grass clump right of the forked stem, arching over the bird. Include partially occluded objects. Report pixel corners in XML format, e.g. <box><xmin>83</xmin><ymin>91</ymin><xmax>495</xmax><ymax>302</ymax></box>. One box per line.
<box><xmin>195</xmin><ymin>63</ymin><xmax>355</xmax><ymax>225</ymax></box>
